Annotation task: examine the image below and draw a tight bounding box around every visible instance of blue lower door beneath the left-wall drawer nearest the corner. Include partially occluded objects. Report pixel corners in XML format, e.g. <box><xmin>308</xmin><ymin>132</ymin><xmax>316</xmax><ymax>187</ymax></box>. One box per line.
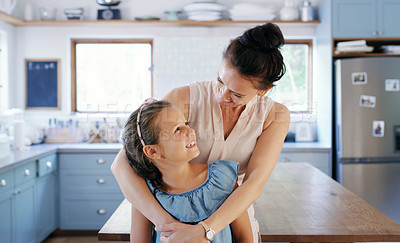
<box><xmin>35</xmin><ymin>173</ymin><xmax>57</xmax><ymax>242</ymax></box>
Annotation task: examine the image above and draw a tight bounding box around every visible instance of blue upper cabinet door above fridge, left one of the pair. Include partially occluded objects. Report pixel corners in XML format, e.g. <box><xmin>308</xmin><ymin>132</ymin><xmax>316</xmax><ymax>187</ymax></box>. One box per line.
<box><xmin>332</xmin><ymin>0</ymin><xmax>378</xmax><ymax>37</ymax></box>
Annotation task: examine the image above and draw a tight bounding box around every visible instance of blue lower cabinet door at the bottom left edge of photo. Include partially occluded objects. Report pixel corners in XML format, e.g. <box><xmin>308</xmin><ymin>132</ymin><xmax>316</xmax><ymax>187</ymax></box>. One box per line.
<box><xmin>0</xmin><ymin>191</ymin><xmax>12</xmax><ymax>242</ymax></box>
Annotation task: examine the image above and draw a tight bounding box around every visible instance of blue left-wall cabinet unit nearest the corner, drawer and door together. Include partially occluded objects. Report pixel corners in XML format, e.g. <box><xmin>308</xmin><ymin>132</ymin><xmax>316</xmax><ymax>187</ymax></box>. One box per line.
<box><xmin>35</xmin><ymin>154</ymin><xmax>58</xmax><ymax>242</ymax></box>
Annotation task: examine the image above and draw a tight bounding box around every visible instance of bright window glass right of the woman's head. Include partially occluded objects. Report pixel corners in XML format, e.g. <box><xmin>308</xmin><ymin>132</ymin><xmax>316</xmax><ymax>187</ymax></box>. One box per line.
<box><xmin>269</xmin><ymin>43</ymin><xmax>312</xmax><ymax>112</ymax></box>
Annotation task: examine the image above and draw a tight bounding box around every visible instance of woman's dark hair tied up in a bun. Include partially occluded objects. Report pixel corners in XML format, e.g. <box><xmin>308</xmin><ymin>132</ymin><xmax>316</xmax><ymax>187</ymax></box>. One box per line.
<box><xmin>223</xmin><ymin>23</ymin><xmax>286</xmax><ymax>90</ymax></box>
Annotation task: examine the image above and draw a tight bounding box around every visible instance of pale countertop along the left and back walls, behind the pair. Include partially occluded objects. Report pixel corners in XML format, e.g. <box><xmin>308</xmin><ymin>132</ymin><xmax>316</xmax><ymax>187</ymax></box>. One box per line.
<box><xmin>0</xmin><ymin>142</ymin><xmax>331</xmax><ymax>173</ymax></box>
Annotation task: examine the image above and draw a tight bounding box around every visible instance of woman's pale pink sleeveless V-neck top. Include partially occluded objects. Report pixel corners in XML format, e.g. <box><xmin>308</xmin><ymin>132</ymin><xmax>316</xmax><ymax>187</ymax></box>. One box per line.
<box><xmin>188</xmin><ymin>81</ymin><xmax>274</xmax><ymax>242</ymax></box>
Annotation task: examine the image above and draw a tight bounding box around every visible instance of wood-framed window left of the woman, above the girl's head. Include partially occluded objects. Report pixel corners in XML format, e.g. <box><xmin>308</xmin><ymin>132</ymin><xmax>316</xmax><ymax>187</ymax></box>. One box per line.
<box><xmin>71</xmin><ymin>39</ymin><xmax>153</xmax><ymax>113</ymax></box>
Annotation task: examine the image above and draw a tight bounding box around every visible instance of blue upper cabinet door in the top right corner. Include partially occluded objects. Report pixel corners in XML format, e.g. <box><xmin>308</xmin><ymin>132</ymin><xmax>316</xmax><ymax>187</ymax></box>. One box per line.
<box><xmin>377</xmin><ymin>0</ymin><xmax>400</xmax><ymax>37</ymax></box>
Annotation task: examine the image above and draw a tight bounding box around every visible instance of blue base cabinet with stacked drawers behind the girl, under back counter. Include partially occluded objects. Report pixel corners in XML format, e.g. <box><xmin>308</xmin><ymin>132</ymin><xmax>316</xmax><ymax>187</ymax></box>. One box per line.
<box><xmin>59</xmin><ymin>153</ymin><xmax>124</xmax><ymax>230</ymax></box>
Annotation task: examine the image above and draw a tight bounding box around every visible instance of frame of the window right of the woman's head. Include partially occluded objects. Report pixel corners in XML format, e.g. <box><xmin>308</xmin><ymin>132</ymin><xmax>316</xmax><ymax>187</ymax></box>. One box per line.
<box><xmin>285</xmin><ymin>39</ymin><xmax>315</xmax><ymax>114</ymax></box>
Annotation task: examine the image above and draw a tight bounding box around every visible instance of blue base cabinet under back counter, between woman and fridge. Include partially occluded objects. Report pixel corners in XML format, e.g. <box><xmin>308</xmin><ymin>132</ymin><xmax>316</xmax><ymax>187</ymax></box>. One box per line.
<box><xmin>278</xmin><ymin>150</ymin><xmax>332</xmax><ymax>177</ymax></box>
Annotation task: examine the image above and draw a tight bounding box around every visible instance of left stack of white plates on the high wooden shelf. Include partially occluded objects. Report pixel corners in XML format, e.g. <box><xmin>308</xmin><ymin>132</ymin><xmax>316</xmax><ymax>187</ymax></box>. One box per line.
<box><xmin>183</xmin><ymin>1</ymin><xmax>226</xmax><ymax>21</ymax></box>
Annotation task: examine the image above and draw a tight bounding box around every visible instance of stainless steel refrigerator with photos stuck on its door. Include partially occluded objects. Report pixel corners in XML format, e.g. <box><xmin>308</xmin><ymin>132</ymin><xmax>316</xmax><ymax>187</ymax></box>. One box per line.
<box><xmin>333</xmin><ymin>57</ymin><xmax>400</xmax><ymax>223</ymax></box>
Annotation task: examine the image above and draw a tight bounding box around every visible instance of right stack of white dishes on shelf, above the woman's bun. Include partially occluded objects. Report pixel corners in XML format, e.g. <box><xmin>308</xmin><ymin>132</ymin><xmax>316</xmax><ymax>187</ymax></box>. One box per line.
<box><xmin>229</xmin><ymin>3</ymin><xmax>276</xmax><ymax>21</ymax></box>
